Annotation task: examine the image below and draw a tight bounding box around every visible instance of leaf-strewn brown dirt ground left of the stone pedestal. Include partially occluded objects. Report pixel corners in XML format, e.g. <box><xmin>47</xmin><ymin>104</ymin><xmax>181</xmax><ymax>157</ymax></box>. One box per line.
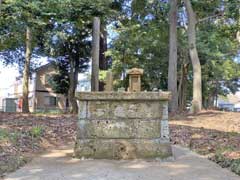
<box><xmin>0</xmin><ymin>113</ymin><xmax>77</xmax><ymax>176</ymax></box>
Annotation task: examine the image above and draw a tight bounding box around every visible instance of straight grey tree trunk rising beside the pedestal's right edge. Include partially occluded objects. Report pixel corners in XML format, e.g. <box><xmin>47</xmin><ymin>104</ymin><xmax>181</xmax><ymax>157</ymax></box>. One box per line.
<box><xmin>168</xmin><ymin>0</ymin><xmax>178</xmax><ymax>112</ymax></box>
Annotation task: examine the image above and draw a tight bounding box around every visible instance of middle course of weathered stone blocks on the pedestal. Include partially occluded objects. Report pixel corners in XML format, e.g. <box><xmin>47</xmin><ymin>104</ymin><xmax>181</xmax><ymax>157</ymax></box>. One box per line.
<box><xmin>78</xmin><ymin>119</ymin><xmax>161</xmax><ymax>139</ymax></box>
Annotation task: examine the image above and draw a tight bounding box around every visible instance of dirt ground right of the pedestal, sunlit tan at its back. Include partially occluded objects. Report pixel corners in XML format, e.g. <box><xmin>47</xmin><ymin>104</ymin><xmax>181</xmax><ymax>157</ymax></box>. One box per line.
<box><xmin>170</xmin><ymin>111</ymin><xmax>240</xmax><ymax>175</ymax></box>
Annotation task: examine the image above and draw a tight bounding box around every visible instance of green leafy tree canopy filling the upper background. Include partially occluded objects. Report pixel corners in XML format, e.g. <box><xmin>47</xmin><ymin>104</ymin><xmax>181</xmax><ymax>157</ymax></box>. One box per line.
<box><xmin>0</xmin><ymin>0</ymin><xmax>240</xmax><ymax>110</ymax></box>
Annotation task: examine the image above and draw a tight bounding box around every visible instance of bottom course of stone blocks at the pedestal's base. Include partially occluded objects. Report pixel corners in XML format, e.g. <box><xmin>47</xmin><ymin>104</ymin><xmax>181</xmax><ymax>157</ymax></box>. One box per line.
<box><xmin>75</xmin><ymin>139</ymin><xmax>172</xmax><ymax>159</ymax></box>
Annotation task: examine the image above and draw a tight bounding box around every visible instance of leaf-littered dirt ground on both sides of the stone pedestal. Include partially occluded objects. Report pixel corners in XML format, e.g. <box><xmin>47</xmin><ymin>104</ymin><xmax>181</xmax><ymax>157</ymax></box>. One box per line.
<box><xmin>0</xmin><ymin>111</ymin><xmax>240</xmax><ymax>175</ymax></box>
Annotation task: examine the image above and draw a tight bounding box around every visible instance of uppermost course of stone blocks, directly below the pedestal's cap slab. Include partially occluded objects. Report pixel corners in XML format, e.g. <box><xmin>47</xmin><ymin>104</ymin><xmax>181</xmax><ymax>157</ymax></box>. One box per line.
<box><xmin>79</xmin><ymin>100</ymin><xmax>163</xmax><ymax>120</ymax></box>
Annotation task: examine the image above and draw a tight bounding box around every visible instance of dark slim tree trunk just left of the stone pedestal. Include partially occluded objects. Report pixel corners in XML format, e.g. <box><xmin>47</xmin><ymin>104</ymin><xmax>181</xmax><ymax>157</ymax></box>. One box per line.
<box><xmin>68</xmin><ymin>59</ymin><xmax>79</xmax><ymax>114</ymax></box>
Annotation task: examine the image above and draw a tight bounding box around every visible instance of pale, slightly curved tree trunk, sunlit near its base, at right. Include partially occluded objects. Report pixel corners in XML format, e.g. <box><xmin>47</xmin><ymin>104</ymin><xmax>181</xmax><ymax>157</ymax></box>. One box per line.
<box><xmin>184</xmin><ymin>0</ymin><xmax>202</xmax><ymax>113</ymax></box>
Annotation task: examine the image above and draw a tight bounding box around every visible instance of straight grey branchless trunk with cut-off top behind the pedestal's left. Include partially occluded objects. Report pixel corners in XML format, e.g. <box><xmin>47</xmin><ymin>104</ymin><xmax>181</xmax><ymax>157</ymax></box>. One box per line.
<box><xmin>91</xmin><ymin>17</ymin><xmax>100</xmax><ymax>91</ymax></box>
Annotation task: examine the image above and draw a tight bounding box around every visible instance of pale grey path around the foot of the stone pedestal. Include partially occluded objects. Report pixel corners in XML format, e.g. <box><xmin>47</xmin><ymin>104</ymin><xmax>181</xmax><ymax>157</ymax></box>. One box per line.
<box><xmin>5</xmin><ymin>146</ymin><xmax>240</xmax><ymax>180</ymax></box>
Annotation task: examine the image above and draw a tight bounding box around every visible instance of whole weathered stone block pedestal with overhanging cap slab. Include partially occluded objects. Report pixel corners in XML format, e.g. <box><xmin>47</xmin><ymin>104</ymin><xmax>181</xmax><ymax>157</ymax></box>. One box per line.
<box><xmin>75</xmin><ymin>92</ymin><xmax>172</xmax><ymax>159</ymax></box>
